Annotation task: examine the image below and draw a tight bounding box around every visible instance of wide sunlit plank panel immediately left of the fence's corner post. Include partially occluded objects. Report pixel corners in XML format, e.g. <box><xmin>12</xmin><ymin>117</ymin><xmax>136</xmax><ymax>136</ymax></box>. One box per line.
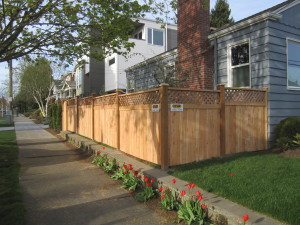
<box><xmin>120</xmin><ymin>105</ymin><xmax>161</xmax><ymax>164</ymax></box>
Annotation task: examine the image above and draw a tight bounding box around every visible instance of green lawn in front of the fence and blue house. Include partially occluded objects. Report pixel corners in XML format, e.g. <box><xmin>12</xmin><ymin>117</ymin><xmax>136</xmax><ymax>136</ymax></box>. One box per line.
<box><xmin>172</xmin><ymin>153</ymin><xmax>300</xmax><ymax>225</ymax></box>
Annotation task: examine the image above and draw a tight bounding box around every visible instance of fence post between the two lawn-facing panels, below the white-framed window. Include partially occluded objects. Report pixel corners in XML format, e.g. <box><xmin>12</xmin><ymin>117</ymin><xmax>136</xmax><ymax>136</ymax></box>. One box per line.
<box><xmin>218</xmin><ymin>84</ymin><xmax>226</xmax><ymax>156</ymax></box>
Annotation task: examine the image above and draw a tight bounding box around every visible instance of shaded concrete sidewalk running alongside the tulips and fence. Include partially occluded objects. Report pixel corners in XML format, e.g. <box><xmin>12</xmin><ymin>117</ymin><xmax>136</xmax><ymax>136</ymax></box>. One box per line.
<box><xmin>15</xmin><ymin>116</ymin><xmax>165</xmax><ymax>225</ymax></box>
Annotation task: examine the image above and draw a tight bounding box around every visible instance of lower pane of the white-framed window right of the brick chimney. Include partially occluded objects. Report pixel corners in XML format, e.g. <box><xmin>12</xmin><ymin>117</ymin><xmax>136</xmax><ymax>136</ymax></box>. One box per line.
<box><xmin>232</xmin><ymin>66</ymin><xmax>250</xmax><ymax>87</ymax></box>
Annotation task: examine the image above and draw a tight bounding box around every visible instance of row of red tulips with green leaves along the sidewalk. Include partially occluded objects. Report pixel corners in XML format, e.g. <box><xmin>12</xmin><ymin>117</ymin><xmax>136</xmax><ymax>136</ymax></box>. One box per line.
<box><xmin>92</xmin><ymin>150</ymin><xmax>244</xmax><ymax>225</ymax></box>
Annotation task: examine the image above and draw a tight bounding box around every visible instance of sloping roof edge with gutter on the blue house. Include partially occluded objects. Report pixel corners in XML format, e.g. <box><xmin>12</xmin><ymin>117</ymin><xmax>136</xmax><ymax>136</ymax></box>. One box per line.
<box><xmin>208</xmin><ymin>0</ymin><xmax>300</xmax><ymax>39</ymax></box>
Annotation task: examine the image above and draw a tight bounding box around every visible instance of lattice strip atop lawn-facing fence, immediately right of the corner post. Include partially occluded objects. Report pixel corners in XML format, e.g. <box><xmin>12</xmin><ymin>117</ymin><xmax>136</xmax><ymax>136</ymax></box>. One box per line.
<box><xmin>168</xmin><ymin>89</ymin><xmax>219</xmax><ymax>104</ymax></box>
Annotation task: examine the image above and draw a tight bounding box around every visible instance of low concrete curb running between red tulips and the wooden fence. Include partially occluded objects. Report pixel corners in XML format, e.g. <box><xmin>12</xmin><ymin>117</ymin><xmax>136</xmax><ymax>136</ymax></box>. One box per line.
<box><xmin>60</xmin><ymin>131</ymin><xmax>284</xmax><ymax>225</ymax></box>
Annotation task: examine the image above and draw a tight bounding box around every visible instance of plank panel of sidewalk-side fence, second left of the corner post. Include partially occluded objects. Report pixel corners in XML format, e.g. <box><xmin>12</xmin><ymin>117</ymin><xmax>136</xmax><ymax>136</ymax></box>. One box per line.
<box><xmin>94</xmin><ymin>105</ymin><xmax>117</xmax><ymax>148</ymax></box>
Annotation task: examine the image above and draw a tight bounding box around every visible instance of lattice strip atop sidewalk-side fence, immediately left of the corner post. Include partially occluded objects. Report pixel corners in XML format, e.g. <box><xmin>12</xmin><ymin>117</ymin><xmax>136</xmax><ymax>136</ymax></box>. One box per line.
<box><xmin>119</xmin><ymin>89</ymin><xmax>160</xmax><ymax>106</ymax></box>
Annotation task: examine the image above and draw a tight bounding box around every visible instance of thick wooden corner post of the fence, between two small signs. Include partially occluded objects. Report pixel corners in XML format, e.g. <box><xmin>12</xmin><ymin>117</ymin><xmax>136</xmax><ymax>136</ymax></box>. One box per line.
<box><xmin>159</xmin><ymin>84</ymin><xmax>170</xmax><ymax>170</ymax></box>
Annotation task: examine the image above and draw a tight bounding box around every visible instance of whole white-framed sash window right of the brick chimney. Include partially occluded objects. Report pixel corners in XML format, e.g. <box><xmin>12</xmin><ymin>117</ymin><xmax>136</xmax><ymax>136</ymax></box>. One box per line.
<box><xmin>228</xmin><ymin>41</ymin><xmax>251</xmax><ymax>87</ymax></box>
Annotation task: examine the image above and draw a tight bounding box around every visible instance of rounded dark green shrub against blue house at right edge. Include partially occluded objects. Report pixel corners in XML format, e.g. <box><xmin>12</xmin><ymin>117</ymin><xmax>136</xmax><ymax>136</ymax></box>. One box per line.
<box><xmin>275</xmin><ymin>117</ymin><xmax>300</xmax><ymax>139</ymax></box>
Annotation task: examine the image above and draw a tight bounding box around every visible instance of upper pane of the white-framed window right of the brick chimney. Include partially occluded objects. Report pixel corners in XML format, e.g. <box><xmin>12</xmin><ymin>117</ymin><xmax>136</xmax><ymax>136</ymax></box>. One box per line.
<box><xmin>231</xmin><ymin>43</ymin><xmax>249</xmax><ymax>66</ymax></box>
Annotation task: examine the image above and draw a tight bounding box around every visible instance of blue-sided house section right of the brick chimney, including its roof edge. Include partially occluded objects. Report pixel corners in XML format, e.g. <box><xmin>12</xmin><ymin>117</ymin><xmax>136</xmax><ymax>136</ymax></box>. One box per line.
<box><xmin>208</xmin><ymin>0</ymin><xmax>300</xmax><ymax>140</ymax></box>
